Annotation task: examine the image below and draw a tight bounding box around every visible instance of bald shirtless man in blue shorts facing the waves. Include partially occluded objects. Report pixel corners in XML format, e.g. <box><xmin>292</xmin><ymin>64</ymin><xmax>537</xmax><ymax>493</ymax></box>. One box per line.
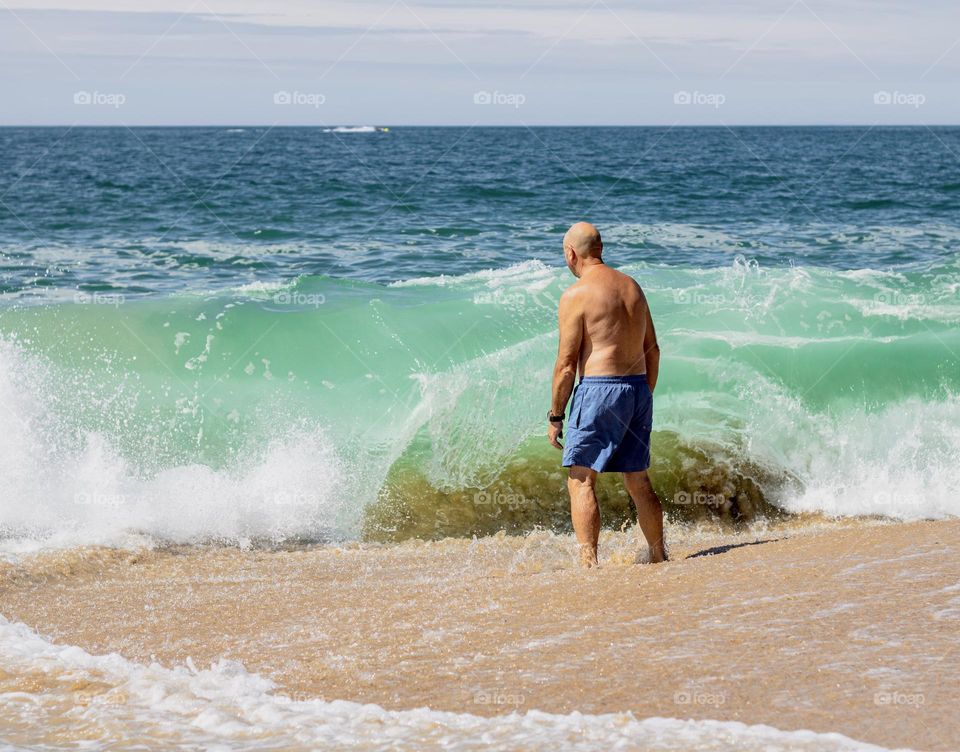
<box><xmin>547</xmin><ymin>222</ymin><xmax>667</xmax><ymax>567</ymax></box>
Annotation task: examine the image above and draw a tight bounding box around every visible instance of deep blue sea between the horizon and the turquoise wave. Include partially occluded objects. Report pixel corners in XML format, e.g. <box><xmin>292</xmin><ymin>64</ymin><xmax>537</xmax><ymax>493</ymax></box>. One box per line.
<box><xmin>0</xmin><ymin>127</ymin><xmax>960</xmax><ymax>300</ymax></box>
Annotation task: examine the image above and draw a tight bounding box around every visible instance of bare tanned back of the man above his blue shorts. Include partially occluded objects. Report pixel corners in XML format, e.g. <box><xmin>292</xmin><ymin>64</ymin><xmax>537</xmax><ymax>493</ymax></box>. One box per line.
<box><xmin>564</xmin><ymin>264</ymin><xmax>656</xmax><ymax>377</ymax></box>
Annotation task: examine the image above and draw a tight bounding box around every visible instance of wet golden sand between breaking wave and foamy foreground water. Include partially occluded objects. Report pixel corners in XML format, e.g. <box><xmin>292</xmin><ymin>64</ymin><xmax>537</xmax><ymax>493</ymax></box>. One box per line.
<box><xmin>0</xmin><ymin>521</ymin><xmax>960</xmax><ymax>750</ymax></box>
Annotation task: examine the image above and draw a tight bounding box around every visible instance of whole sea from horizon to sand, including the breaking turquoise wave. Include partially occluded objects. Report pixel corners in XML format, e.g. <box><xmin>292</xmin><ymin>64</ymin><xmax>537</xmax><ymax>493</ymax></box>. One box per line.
<box><xmin>0</xmin><ymin>128</ymin><xmax>960</xmax><ymax>542</ymax></box>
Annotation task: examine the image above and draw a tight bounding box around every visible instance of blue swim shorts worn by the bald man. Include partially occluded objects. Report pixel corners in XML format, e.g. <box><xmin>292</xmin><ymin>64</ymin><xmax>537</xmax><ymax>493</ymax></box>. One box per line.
<box><xmin>563</xmin><ymin>375</ymin><xmax>653</xmax><ymax>473</ymax></box>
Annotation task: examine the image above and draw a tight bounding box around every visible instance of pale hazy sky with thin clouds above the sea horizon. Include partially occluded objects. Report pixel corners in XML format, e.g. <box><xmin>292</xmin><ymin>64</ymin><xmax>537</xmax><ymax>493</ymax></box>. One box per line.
<box><xmin>0</xmin><ymin>0</ymin><xmax>960</xmax><ymax>126</ymax></box>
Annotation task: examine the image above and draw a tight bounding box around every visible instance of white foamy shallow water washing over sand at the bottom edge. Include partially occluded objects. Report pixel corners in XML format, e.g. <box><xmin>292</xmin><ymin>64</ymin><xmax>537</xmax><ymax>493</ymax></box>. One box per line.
<box><xmin>0</xmin><ymin>617</ymin><xmax>912</xmax><ymax>752</ymax></box>
